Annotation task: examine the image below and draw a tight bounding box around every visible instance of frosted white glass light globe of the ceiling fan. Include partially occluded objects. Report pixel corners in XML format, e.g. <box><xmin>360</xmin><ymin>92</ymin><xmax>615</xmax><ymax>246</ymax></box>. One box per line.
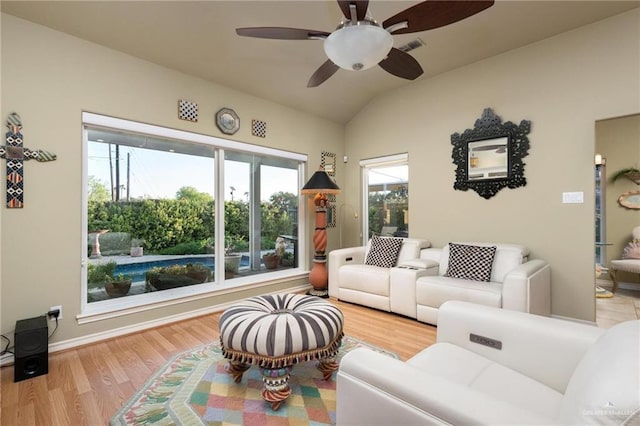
<box><xmin>324</xmin><ymin>23</ymin><xmax>393</xmax><ymax>71</ymax></box>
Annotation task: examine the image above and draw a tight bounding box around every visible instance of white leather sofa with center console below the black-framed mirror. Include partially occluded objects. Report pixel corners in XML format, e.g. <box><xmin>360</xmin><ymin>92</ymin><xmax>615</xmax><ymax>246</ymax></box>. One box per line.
<box><xmin>329</xmin><ymin>238</ymin><xmax>551</xmax><ymax>325</ymax></box>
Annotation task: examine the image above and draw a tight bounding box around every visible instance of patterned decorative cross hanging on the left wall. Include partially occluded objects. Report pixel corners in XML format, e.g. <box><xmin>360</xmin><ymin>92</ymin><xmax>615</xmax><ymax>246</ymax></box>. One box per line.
<box><xmin>0</xmin><ymin>112</ymin><xmax>57</xmax><ymax>209</ymax></box>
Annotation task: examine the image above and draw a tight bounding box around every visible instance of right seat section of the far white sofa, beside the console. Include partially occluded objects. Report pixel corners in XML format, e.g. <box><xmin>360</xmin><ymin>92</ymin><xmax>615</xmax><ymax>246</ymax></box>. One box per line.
<box><xmin>416</xmin><ymin>243</ymin><xmax>551</xmax><ymax>325</ymax></box>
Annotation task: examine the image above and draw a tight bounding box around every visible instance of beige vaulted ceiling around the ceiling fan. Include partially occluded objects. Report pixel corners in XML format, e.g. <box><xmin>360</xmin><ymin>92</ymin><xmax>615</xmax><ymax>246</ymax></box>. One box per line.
<box><xmin>1</xmin><ymin>0</ymin><xmax>640</xmax><ymax>123</ymax></box>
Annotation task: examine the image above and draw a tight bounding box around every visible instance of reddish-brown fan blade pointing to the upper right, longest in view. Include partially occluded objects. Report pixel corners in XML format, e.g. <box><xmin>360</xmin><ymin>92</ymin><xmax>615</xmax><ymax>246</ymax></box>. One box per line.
<box><xmin>382</xmin><ymin>0</ymin><xmax>494</xmax><ymax>34</ymax></box>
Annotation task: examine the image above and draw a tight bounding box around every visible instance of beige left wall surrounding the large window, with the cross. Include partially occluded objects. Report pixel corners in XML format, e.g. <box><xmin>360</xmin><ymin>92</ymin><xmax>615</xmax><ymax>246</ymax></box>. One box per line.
<box><xmin>0</xmin><ymin>14</ymin><xmax>344</xmax><ymax>342</ymax></box>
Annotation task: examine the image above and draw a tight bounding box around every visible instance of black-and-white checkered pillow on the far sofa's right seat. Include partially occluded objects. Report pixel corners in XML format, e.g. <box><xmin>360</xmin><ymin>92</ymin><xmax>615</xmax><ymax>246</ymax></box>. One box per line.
<box><xmin>445</xmin><ymin>243</ymin><xmax>496</xmax><ymax>282</ymax></box>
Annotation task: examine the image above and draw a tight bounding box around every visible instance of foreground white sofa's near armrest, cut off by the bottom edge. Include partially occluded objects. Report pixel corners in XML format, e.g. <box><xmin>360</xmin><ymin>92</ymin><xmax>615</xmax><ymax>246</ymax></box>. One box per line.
<box><xmin>336</xmin><ymin>348</ymin><xmax>549</xmax><ymax>425</ymax></box>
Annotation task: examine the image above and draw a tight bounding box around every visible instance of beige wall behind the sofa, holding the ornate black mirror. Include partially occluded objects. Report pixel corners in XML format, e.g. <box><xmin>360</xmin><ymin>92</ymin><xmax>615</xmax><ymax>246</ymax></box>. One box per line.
<box><xmin>343</xmin><ymin>9</ymin><xmax>640</xmax><ymax>320</ymax></box>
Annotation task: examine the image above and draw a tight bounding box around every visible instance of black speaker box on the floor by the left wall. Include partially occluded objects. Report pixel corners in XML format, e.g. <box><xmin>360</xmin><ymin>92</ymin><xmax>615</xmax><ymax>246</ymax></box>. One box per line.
<box><xmin>13</xmin><ymin>316</ymin><xmax>49</xmax><ymax>382</ymax></box>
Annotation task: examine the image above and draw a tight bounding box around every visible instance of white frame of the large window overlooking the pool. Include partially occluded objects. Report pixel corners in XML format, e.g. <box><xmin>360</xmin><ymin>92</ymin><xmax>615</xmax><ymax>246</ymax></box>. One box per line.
<box><xmin>77</xmin><ymin>112</ymin><xmax>308</xmax><ymax>324</ymax></box>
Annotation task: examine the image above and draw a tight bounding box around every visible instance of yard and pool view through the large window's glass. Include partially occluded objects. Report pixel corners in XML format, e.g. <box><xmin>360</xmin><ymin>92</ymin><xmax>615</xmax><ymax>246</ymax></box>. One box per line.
<box><xmin>87</xmin><ymin>129</ymin><xmax>299</xmax><ymax>303</ymax></box>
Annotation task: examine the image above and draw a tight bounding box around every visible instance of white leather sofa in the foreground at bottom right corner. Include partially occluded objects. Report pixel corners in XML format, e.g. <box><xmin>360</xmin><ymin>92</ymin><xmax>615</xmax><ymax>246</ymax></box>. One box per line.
<box><xmin>336</xmin><ymin>302</ymin><xmax>640</xmax><ymax>425</ymax></box>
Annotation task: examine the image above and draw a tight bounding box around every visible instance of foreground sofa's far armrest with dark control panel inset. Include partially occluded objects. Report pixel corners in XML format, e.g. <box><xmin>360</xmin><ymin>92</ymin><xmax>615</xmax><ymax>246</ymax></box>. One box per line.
<box><xmin>437</xmin><ymin>301</ymin><xmax>604</xmax><ymax>393</ymax></box>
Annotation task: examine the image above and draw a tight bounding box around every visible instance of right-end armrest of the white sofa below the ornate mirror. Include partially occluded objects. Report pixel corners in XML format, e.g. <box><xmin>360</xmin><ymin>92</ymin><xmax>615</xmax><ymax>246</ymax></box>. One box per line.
<box><xmin>502</xmin><ymin>259</ymin><xmax>551</xmax><ymax>316</ymax></box>
